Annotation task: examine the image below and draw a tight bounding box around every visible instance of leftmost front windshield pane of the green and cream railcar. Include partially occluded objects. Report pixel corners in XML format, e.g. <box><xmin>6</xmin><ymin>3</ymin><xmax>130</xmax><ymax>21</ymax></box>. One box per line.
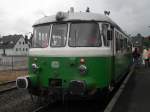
<box><xmin>32</xmin><ymin>25</ymin><xmax>50</xmax><ymax>48</ymax></box>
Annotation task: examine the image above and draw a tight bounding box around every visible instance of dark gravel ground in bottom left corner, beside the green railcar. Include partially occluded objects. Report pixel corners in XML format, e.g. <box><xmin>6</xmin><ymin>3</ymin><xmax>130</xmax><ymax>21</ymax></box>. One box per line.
<box><xmin>0</xmin><ymin>89</ymin><xmax>36</xmax><ymax>112</ymax></box>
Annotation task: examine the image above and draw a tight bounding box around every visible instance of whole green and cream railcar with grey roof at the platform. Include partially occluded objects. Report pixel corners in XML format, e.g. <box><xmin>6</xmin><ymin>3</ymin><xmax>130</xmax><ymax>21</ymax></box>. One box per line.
<box><xmin>16</xmin><ymin>12</ymin><xmax>131</xmax><ymax>99</ymax></box>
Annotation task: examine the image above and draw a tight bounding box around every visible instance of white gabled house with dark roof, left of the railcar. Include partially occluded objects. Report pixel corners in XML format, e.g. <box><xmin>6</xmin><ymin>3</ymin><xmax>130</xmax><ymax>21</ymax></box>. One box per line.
<box><xmin>0</xmin><ymin>35</ymin><xmax>29</xmax><ymax>56</ymax></box>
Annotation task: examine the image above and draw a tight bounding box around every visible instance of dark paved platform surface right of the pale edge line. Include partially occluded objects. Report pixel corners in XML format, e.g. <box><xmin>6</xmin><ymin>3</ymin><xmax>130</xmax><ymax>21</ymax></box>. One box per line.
<box><xmin>112</xmin><ymin>66</ymin><xmax>150</xmax><ymax>112</ymax></box>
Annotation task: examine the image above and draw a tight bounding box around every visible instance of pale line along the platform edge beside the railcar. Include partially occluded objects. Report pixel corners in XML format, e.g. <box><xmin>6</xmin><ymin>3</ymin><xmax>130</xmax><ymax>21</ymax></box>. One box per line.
<box><xmin>104</xmin><ymin>65</ymin><xmax>134</xmax><ymax>112</ymax></box>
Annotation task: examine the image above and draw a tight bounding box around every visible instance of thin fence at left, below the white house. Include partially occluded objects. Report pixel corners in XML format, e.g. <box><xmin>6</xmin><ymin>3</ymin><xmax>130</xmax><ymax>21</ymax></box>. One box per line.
<box><xmin>0</xmin><ymin>56</ymin><xmax>28</xmax><ymax>70</ymax></box>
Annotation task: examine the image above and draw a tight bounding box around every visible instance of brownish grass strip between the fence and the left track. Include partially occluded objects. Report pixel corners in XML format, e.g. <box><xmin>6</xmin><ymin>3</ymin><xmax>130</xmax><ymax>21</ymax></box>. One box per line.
<box><xmin>0</xmin><ymin>70</ymin><xmax>28</xmax><ymax>83</ymax></box>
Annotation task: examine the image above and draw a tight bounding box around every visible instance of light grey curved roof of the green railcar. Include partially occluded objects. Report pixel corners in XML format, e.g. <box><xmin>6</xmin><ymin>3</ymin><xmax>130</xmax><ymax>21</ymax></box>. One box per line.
<box><xmin>33</xmin><ymin>12</ymin><xmax>125</xmax><ymax>37</ymax></box>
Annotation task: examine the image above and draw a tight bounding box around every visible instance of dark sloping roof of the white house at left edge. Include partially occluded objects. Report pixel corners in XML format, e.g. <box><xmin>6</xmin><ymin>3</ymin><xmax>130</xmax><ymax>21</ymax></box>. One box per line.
<box><xmin>0</xmin><ymin>35</ymin><xmax>23</xmax><ymax>49</ymax></box>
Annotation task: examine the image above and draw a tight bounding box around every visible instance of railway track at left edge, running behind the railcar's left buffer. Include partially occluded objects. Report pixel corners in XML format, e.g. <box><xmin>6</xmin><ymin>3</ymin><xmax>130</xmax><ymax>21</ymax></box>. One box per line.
<box><xmin>0</xmin><ymin>81</ymin><xmax>17</xmax><ymax>94</ymax></box>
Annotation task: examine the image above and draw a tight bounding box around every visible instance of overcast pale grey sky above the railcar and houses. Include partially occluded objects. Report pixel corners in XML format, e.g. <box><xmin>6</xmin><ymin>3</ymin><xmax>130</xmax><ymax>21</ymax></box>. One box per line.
<box><xmin>0</xmin><ymin>0</ymin><xmax>150</xmax><ymax>36</ymax></box>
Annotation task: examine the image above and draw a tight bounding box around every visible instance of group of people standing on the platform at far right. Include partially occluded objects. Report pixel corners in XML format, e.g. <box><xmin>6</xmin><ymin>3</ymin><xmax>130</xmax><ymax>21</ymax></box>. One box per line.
<box><xmin>132</xmin><ymin>48</ymin><xmax>150</xmax><ymax>68</ymax></box>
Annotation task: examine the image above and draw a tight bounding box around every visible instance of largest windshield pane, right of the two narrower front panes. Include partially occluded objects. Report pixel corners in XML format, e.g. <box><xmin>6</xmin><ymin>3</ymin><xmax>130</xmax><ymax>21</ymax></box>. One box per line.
<box><xmin>69</xmin><ymin>22</ymin><xmax>102</xmax><ymax>47</ymax></box>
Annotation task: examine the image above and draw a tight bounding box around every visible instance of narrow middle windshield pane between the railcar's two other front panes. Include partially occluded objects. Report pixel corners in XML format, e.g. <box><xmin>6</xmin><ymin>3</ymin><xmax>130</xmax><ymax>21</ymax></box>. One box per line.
<box><xmin>51</xmin><ymin>24</ymin><xmax>67</xmax><ymax>47</ymax></box>
